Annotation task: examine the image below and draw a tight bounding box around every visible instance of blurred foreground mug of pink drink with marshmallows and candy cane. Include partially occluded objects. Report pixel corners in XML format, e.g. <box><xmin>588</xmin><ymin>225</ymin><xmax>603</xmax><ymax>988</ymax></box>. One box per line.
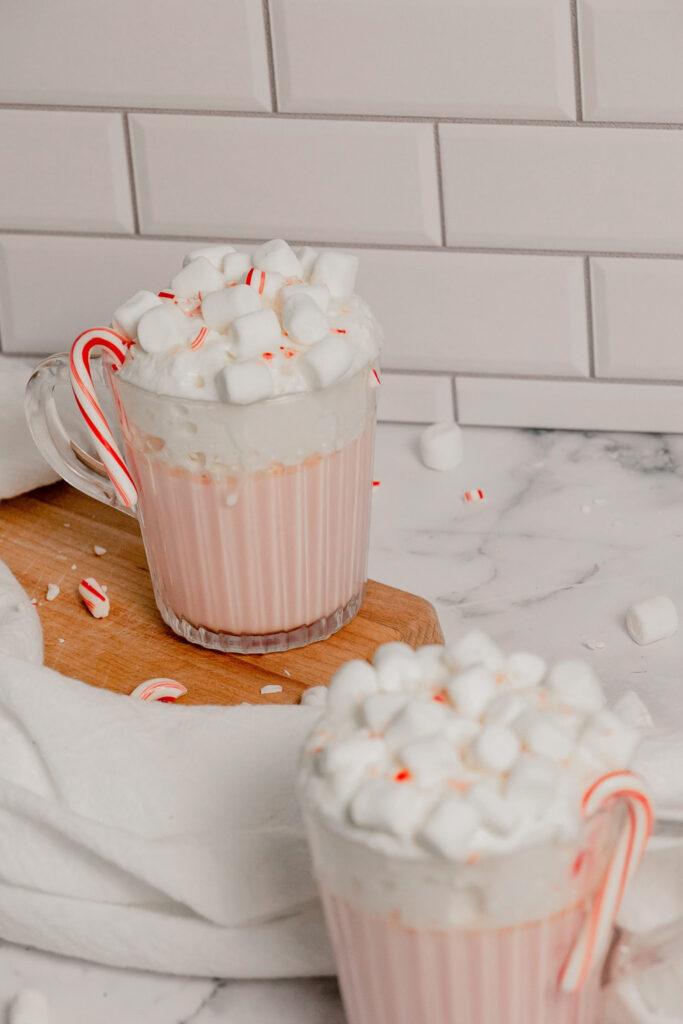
<box><xmin>299</xmin><ymin>631</ymin><xmax>652</xmax><ymax>1024</ymax></box>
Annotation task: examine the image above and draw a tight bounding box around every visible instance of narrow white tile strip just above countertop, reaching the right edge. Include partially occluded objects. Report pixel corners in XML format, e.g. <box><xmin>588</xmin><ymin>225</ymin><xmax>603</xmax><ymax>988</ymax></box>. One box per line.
<box><xmin>456</xmin><ymin>377</ymin><xmax>683</xmax><ymax>433</ymax></box>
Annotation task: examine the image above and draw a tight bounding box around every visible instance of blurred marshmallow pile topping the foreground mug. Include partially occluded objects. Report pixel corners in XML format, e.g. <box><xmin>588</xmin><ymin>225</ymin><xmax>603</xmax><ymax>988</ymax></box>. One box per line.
<box><xmin>303</xmin><ymin>631</ymin><xmax>640</xmax><ymax>861</ymax></box>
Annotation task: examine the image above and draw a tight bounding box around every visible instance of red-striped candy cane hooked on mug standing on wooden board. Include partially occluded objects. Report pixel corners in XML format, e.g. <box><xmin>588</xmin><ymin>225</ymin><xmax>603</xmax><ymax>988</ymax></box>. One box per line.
<box><xmin>69</xmin><ymin>327</ymin><xmax>137</xmax><ymax>508</ymax></box>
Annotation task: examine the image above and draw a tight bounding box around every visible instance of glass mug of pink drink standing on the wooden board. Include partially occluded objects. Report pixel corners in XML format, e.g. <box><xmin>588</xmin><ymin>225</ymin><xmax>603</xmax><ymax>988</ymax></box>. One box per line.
<box><xmin>27</xmin><ymin>243</ymin><xmax>379</xmax><ymax>653</ymax></box>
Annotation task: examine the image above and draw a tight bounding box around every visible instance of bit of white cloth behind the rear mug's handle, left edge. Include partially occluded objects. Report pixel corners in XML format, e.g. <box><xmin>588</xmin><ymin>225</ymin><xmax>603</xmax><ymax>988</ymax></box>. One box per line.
<box><xmin>0</xmin><ymin>355</ymin><xmax>58</xmax><ymax>500</ymax></box>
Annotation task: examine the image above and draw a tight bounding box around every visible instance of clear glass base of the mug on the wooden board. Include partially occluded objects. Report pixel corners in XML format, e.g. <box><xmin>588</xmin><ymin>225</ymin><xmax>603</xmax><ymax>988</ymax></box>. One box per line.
<box><xmin>157</xmin><ymin>585</ymin><xmax>366</xmax><ymax>654</ymax></box>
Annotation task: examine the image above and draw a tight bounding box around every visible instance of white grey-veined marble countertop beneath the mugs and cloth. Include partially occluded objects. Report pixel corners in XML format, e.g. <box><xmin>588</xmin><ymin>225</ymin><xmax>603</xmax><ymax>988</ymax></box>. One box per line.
<box><xmin>5</xmin><ymin>424</ymin><xmax>683</xmax><ymax>1024</ymax></box>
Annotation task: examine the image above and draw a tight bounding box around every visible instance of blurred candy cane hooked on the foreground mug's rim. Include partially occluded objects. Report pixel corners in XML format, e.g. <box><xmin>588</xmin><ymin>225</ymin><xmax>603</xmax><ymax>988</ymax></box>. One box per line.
<box><xmin>560</xmin><ymin>771</ymin><xmax>653</xmax><ymax>992</ymax></box>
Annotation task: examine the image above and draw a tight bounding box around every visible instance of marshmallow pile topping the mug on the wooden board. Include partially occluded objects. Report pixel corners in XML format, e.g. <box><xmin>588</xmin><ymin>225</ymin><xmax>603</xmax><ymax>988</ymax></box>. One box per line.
<box><xmin>112</xmin><ymin>239</ymin><xmax>379</xmax><ymax>404</ymax></box>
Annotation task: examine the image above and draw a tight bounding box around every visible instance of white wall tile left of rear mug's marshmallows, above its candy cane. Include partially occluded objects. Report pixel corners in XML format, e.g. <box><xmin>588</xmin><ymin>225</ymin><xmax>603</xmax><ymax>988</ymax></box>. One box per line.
<box><xmin>0</xmin><ymin>234</ymin><xmax>191</xmax><ymax>352</ymax></box>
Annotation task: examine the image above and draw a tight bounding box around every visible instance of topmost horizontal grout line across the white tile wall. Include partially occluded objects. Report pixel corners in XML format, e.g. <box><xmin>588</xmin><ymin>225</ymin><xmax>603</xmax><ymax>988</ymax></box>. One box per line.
<box><xmin>0</xmin><ymin>101</ymin><xmax>683</xmax><ymax>131</ymax></box>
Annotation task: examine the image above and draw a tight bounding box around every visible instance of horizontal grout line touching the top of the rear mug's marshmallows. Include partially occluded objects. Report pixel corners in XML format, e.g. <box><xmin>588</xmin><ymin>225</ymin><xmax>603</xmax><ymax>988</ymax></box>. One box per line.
<box><xmin>0</xmin><ymin>227</ymin><xmax>683</xmax><ymax>261</ymax></box>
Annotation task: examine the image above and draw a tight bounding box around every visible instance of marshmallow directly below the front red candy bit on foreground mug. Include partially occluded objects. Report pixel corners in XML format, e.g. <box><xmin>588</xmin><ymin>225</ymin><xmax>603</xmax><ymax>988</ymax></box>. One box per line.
<box><xmin>349</xmin><ymin>778</ymin><xmax>432</xmax><ymax>839</ymax></box>
